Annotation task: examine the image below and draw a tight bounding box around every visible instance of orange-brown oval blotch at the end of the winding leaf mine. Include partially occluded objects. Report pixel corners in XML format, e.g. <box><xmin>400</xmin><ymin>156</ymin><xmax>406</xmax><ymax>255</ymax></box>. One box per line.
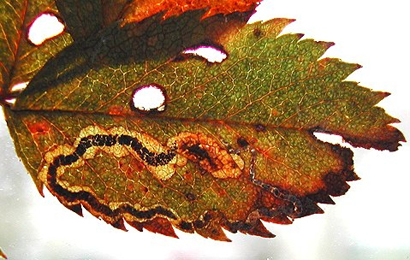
<box><xmin>168</xmin><ymin>132</ymin><xmax>243</xmax><ymax>178</ymax></box>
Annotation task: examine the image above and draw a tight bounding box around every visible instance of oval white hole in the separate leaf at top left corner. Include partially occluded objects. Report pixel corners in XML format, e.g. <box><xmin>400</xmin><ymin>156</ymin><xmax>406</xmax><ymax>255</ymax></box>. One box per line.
<box><xmin>28</xmin><ymin>13</ymin><xmax>65</xmax><ymax>46</ymax></box>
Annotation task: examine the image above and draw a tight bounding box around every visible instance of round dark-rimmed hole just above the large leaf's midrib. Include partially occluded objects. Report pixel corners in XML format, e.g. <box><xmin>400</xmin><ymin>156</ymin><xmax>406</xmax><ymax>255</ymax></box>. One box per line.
<box><xmin>131</xmin><ymin>83</ymin><xmax>166</xmax><ymax>113</ymax></box>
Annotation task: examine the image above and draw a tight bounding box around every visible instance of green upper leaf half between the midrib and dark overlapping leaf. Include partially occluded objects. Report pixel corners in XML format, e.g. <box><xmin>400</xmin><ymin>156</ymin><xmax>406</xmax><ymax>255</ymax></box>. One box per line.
<box><xmin>16</xmin><ymin>19</ymin><xmax>404</xmax><ymax>150</ymax></box>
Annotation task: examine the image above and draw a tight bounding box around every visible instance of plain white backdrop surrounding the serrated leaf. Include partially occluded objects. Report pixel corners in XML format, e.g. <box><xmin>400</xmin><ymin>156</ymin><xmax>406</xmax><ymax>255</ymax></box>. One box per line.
<box><xmin>0</xmin><ymin>0</ymin><xmax>410</xmax><ymax>260</ymax></box>
